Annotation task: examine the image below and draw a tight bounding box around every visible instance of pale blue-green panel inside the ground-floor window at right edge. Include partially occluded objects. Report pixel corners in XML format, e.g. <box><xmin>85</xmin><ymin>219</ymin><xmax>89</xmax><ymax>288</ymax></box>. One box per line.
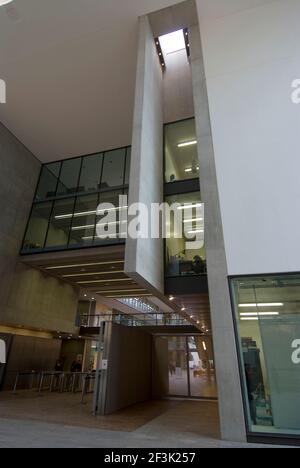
<box><xmin>260</xmin><ymin>315</ymin><xmax>300</xmax><ymax>430</ymax></box>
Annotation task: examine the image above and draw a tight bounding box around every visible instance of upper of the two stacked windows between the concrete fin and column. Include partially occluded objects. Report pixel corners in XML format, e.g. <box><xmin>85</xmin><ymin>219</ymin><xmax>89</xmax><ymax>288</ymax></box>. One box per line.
<box><xmin>165</xmin><ymin>119</ymin><xmax>199</xmax><ymax>183</ymax></box>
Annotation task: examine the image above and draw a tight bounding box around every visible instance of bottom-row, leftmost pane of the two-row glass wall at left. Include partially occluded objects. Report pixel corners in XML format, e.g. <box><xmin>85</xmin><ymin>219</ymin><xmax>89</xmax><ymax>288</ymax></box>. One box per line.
<box><xmin>23</xmin><ymin>202</ymin><xmax>52</xmax><ymax>250</ymax></box>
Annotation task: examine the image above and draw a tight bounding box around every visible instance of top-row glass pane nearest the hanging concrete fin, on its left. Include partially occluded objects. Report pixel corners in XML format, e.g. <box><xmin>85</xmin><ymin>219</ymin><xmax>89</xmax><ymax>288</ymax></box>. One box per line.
<box><xmin>101</xmin><ymin>148</ymin><xmax>126</xmax><ymax>190</ymax></box>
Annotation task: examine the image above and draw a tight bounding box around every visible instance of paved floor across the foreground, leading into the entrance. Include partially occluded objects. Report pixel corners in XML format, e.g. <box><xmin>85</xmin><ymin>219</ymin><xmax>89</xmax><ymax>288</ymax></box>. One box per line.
<box><xmin>0</xmin><ymin>392</ymin><xmax>278</xmax><ymax>448</ymax></box>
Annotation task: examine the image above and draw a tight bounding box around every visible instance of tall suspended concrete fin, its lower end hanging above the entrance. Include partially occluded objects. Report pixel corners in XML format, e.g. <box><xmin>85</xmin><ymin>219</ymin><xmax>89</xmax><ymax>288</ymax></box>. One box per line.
<box><xmin>125</xmin><ymin>16</ymin><xmax>164</xmax><ymax>294</ymax></box>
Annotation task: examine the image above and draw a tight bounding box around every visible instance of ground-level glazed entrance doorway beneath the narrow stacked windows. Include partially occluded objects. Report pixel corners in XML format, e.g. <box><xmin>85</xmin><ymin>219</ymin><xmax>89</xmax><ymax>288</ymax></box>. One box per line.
<box><xmin>153</xmin><ymin>335</ymin><xmax>217</xmax><ymax>399</ymax></box>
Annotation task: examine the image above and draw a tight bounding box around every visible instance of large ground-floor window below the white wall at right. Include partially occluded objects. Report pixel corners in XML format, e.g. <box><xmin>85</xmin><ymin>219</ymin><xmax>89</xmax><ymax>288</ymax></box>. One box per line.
<box><xmin>232</xmin><ymin>275</ymin><xmax>300</xmax><ymax>435</ymax></box>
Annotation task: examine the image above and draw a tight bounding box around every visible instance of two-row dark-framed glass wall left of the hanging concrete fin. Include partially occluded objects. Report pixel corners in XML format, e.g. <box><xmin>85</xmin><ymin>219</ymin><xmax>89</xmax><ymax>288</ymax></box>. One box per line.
<box><xmin>22</xmin><ymin>147</ymin><xmax>131</xmax><ymax>253</ymax></box>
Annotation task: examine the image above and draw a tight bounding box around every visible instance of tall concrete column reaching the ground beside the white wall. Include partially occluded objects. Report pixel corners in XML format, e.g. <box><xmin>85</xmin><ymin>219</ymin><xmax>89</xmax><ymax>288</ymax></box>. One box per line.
<box><xmin>190</xmin><ymin>26</ymin><xmax>246</xmax><ymax>441</ymax></box>
